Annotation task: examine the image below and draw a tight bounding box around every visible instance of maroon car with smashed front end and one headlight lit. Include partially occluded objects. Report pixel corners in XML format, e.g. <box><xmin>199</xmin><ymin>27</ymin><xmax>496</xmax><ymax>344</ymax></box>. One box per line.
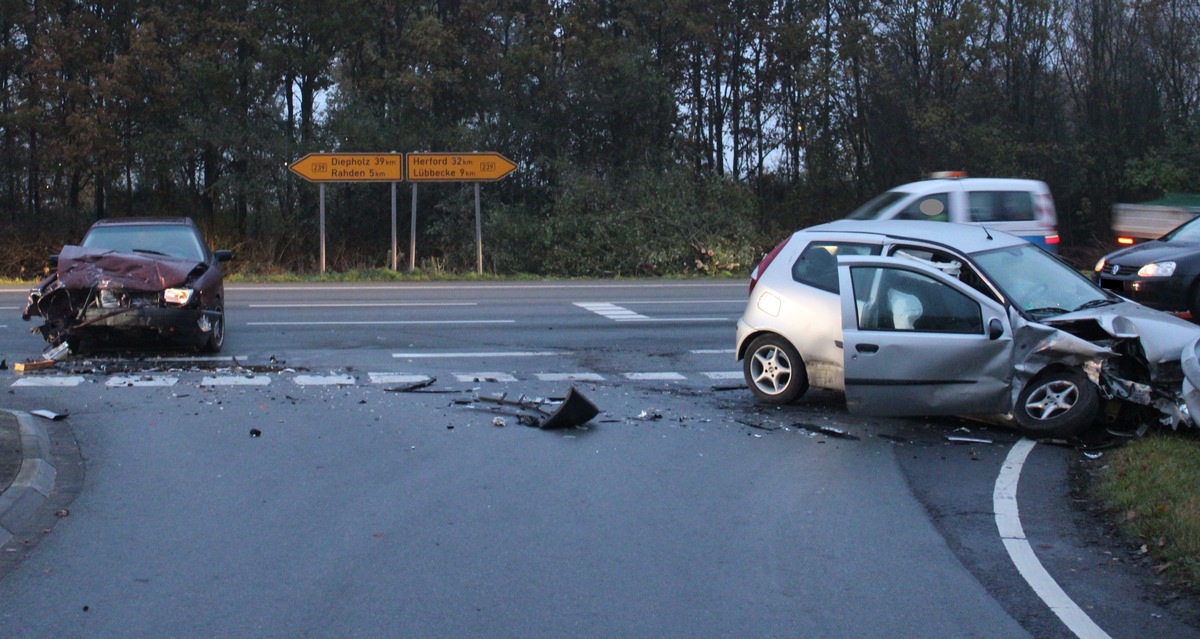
<box><xmin>22</xmin><ymin>217</ymin><xmax>233</xmax><ymax>353</ymax></box>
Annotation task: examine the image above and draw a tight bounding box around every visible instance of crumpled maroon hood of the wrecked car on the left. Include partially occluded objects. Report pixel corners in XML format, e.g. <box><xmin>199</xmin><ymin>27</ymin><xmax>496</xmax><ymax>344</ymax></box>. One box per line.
<box><xmin>58</xmin><ymin>245</ymin><xmax>204</xmax><ymax>293</ymax></box>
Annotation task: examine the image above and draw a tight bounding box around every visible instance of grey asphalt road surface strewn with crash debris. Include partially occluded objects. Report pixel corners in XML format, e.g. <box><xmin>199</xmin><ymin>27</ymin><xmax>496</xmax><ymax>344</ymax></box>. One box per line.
<box><xmin>0</xmin><ymin>281</ymin><xmax>1200</xmax><ymax>638</ymax></box>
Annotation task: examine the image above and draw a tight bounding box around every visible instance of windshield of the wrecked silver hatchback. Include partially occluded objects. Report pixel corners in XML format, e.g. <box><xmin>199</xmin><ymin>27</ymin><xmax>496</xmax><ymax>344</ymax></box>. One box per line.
<box><xmin>972</xmin><ymin>244</ymin><xmax>1118</xmax><ymax>320</ymax></box>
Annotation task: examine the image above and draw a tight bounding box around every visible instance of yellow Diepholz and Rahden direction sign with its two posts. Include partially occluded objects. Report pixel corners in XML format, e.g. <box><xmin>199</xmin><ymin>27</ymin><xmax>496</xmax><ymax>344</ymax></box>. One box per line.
<box><xmin>288</xmin><ymin>153</ymin><xmax>404</xmax><ymax>275</ymax></box>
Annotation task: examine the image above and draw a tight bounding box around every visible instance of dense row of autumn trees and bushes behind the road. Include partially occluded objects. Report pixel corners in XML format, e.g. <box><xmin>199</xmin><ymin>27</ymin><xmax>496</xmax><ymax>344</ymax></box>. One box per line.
<box><xmin>0</xmin><ymin>0</ymin><xmax>1200</xmax><ymax>275</ymax></box>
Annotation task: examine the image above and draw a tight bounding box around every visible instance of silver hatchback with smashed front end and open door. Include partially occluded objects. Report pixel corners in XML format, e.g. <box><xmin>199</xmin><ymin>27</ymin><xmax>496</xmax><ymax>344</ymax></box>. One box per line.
<box><xmin>737</xmin><ymin>220</ymin><xmax>1200</xmax><ymax>437</ymax></box>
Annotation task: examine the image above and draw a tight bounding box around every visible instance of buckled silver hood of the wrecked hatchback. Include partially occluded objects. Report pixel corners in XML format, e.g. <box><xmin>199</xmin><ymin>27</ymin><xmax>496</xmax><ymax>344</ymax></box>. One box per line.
<box><xmin>1043</xmin><ymin>301</ymin><xmax>1200</xmax><ymax>364</ymax></box>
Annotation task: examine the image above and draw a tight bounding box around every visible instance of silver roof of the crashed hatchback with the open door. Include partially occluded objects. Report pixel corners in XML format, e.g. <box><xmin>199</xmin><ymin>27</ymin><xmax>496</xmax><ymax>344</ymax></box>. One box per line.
<box><xmin>797</xmin><ymin>220</ymin><xmax>1028</xmax><ymax>253</ymax></box>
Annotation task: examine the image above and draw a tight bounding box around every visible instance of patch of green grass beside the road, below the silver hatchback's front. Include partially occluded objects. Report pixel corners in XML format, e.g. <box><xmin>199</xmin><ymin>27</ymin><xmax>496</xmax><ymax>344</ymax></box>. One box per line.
<box><xmin>1096</xmin><ymin>434</ymin><xmax>1200</xmax><ymax>592</ymax></box>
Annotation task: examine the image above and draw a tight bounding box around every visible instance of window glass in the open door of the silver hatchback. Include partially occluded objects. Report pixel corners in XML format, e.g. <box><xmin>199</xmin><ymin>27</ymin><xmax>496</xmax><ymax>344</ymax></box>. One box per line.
<box><xmin>851</xmin><ymin>267</ymin><xmax>983</xmax><ymax>334</ymax></box>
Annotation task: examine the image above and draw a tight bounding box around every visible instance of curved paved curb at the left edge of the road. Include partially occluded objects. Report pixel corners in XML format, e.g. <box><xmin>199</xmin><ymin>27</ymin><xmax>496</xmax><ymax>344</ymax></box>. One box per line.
<box><xmin>0</xmin><ymin>408</ymin><xmax>58</xmax><ymax>545</ymax></box>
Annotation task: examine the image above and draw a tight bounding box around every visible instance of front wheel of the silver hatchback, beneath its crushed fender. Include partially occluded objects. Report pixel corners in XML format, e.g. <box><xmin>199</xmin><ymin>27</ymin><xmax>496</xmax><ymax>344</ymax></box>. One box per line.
<box><xmin>1013</xmin><ymin>369</ymin><xmax>1100</xmax><ymax>438</ymax></box>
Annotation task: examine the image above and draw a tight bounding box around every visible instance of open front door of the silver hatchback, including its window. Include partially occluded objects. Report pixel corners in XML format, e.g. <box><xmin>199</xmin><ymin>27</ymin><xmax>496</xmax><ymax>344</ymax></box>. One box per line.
<box><xmin>838</xmin><ymin>257</ymin><xmax>1013</xmax><ymax>416</ymax></box>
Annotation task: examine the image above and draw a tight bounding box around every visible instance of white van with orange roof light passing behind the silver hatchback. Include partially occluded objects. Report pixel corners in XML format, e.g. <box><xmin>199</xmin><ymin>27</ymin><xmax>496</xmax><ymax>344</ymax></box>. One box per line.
<box><xmin>847</xmin><ymin>172</ymin><xmax>1058</xmax><ymax>252</ymax></box>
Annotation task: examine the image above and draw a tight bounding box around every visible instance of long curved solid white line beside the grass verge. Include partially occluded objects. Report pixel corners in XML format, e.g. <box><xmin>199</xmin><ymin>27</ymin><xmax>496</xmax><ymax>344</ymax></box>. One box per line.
<box><xmin>991</xmin><ymin>438</ymin><xmax>1109</xmax><ymax>639</ymax></box>
